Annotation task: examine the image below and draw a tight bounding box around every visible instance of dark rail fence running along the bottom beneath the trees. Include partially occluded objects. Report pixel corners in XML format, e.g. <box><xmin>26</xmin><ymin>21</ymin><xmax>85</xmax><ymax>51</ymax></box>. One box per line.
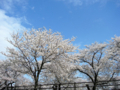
<box><xmin>1</xmin><ymin>80</ymin><xmax>120</xmax><ymax>90</ymax></box>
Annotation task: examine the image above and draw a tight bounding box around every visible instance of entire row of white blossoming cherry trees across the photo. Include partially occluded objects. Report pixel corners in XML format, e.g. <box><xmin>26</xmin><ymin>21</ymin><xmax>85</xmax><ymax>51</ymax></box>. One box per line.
<box><xmin>0</xmin><ymin>28</ymin><xmax>120</xmax><ymax>90</ymax></box>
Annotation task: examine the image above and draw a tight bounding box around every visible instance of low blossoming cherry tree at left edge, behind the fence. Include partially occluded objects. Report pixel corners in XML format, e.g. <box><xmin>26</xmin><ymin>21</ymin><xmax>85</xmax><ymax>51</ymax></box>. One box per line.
<box><xmin>0</xmin><ymin>60</ymin><xmax>21</xmax><ymax>88</ymax></box>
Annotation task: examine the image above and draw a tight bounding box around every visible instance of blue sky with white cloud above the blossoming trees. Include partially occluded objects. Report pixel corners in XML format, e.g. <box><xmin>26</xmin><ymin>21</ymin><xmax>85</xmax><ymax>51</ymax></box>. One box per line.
<box><xmin>0</xmin><ymin>0</ymin><xmax>120</xmax><ymax>58</ymax></box>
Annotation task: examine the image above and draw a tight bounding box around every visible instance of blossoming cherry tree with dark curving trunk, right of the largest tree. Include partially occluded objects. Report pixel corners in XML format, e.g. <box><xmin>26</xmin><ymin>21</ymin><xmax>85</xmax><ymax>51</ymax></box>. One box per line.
<box><xmin>76</xmin><ymin>42</ymin><xmax>116</xmax><ymax>90</ymax></box>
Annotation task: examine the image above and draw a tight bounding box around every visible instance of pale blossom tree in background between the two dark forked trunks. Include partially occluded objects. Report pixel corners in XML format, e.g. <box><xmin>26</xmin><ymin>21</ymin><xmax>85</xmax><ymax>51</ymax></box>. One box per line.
<box><xmin>39</xmin><ymin>58</ymin><xmax>76</xmax><ymax>90</ymax></box>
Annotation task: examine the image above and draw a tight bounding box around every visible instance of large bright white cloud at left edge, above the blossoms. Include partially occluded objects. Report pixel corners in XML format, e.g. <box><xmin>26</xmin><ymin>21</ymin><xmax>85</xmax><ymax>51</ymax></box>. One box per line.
<box><xmin>0</xmin><ymin>9</ymin><xmax>26</xmax><ymax>59</ymax></box>
